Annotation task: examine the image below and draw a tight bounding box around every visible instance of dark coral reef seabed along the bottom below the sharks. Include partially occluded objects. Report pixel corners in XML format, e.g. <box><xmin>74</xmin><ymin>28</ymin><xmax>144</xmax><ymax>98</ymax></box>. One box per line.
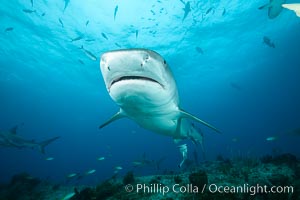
<box><xmin>0</xmin><ymin>154</ymin><xmax>300</xmax><ymax>200</ymax></box>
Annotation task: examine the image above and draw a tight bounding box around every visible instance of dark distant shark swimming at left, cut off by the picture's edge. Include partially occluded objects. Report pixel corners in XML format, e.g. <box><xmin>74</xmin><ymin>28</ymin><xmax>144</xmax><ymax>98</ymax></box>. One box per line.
<box><xmin>0</xmin><ymin>126</ymin><xmax>59</xmax><ymax>154</ymax></box>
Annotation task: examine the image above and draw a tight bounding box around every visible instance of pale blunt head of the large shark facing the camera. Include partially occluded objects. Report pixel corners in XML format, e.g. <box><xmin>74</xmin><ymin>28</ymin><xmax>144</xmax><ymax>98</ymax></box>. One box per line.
<box><xmin>100</xmin><ymin>49</ymin><xmax>177</xmax><ymax>107</ymax></box>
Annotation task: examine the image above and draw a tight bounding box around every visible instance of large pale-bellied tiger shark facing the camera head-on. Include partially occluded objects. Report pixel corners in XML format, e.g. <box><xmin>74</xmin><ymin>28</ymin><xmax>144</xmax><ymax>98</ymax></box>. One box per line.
<box><xmin>99</xmin><ymin>49</ymin><xmax>220</xmax><ymax>144</ymax></box>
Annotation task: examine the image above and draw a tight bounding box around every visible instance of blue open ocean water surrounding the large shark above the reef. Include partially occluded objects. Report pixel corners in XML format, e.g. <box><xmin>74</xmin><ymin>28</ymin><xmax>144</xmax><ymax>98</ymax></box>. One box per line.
<box><xmin>0</xmin><ymin>0</ymin><xmax>300</xmax><ymax>184</ymax></box>
